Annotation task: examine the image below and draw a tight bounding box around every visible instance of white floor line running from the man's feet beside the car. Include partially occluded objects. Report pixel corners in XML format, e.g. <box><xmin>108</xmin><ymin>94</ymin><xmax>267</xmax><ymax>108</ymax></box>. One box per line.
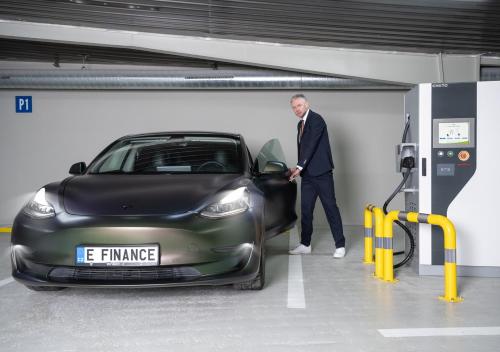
<box><xmin>286</xmin><ymin>227</ymin><xmax>306</xmax><ymax>309</ymax></box>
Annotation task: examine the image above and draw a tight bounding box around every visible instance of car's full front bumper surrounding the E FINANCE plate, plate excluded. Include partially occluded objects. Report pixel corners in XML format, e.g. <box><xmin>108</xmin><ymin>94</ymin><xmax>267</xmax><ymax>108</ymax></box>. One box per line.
<box><xmin>11</xmin><ymin>209</ymin><xmax>263</xmax><ymax>287</ymax></box>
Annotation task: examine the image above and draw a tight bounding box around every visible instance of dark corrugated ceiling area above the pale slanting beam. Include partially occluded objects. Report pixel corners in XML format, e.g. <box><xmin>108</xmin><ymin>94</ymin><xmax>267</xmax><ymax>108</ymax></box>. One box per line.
<box><xmin>0</xmin><ymin>0</ymin><xmax>500</xmax><ymax>54</ymax></box>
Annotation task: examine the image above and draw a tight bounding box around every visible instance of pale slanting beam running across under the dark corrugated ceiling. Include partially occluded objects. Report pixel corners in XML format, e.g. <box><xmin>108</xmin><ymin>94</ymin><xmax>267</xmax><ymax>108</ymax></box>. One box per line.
<box><xmin>0</xmin><ymin>20</ymin><xmax>481</xmax><ymax>84</ymax></box>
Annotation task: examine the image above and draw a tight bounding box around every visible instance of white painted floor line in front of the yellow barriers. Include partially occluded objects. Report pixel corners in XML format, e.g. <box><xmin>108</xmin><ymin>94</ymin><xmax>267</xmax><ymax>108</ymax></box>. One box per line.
<box><xmin>378</xmin><ymin>326</ymin><xmax>500</xmax><ymax>337</ymax></box>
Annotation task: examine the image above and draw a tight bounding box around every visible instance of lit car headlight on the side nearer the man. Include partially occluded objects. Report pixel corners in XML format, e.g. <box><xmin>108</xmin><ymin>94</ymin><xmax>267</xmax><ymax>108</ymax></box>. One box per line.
<box><xmin>200</xmin><ymin>187</ymin><xmax>250</xmax><ymax>218</ymax></box>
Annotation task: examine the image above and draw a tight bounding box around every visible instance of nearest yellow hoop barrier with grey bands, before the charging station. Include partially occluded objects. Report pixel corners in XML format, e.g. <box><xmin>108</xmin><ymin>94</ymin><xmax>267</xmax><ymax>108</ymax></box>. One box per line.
<box><xmin>384</xmin><ymin>210</ymin><xmax>463</xmax><ymax>302</ymax></box>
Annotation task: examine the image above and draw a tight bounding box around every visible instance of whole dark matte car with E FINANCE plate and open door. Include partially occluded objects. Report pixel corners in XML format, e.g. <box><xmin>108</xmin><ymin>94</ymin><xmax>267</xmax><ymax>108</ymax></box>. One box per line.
<box><xmin>11</xmin><ymin>132</ymin><xmax>297</xmax><ymax>290</ymax></box>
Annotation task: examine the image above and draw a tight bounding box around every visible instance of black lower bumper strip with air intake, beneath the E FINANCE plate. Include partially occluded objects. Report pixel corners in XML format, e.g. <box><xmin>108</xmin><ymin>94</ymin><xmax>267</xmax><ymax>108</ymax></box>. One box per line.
<box><xmin>12</xmin><ymin>244</ymin><xmax>260</xmax><ymax>287</ymax></box>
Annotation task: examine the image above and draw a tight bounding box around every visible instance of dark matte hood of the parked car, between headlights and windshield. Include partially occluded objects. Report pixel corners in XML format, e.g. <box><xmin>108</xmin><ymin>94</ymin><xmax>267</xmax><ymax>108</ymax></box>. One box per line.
<box><xmin>63</xmin><ymin>174</ymin><xmax>244</xmax><ymax>216</ymax></box>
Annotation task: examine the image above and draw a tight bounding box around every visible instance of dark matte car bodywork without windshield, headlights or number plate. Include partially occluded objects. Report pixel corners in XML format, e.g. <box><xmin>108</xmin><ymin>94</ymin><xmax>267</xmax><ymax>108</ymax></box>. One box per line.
<box><xmin>11</xmin><ymin>132</ymin><xmax>297</xmax><ymax>290</ymax></box>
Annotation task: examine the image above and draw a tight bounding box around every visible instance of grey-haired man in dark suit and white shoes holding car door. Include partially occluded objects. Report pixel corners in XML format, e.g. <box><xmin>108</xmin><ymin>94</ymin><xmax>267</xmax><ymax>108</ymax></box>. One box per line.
<box><xmin>290</xmin><ymin>94</ymin><xmax>345</xmax><ymax>258</ymax></box>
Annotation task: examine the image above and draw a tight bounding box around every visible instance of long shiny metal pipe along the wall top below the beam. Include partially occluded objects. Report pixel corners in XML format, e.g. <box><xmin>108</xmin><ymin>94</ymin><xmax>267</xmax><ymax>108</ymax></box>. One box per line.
<box><xmin>0</xmin><ymin>70</ymin><xmax>411</xmax><ymax>90</ymax></box>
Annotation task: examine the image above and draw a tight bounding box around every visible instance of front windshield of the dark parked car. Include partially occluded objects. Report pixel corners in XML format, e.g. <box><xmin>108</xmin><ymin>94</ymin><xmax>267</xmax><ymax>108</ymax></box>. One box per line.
<box><xmin>89</xmin><ymin>135</ymin><xmax>242</xmax><ymax>174</ymax></box>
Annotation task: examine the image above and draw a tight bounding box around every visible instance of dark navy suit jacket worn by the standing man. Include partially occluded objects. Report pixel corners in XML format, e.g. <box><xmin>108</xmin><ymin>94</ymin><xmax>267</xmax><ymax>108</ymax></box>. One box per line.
<box><xmin>297</xmin><ymin>110</ymin><xmax>333</xmax><ymax>176</ymax></box>
